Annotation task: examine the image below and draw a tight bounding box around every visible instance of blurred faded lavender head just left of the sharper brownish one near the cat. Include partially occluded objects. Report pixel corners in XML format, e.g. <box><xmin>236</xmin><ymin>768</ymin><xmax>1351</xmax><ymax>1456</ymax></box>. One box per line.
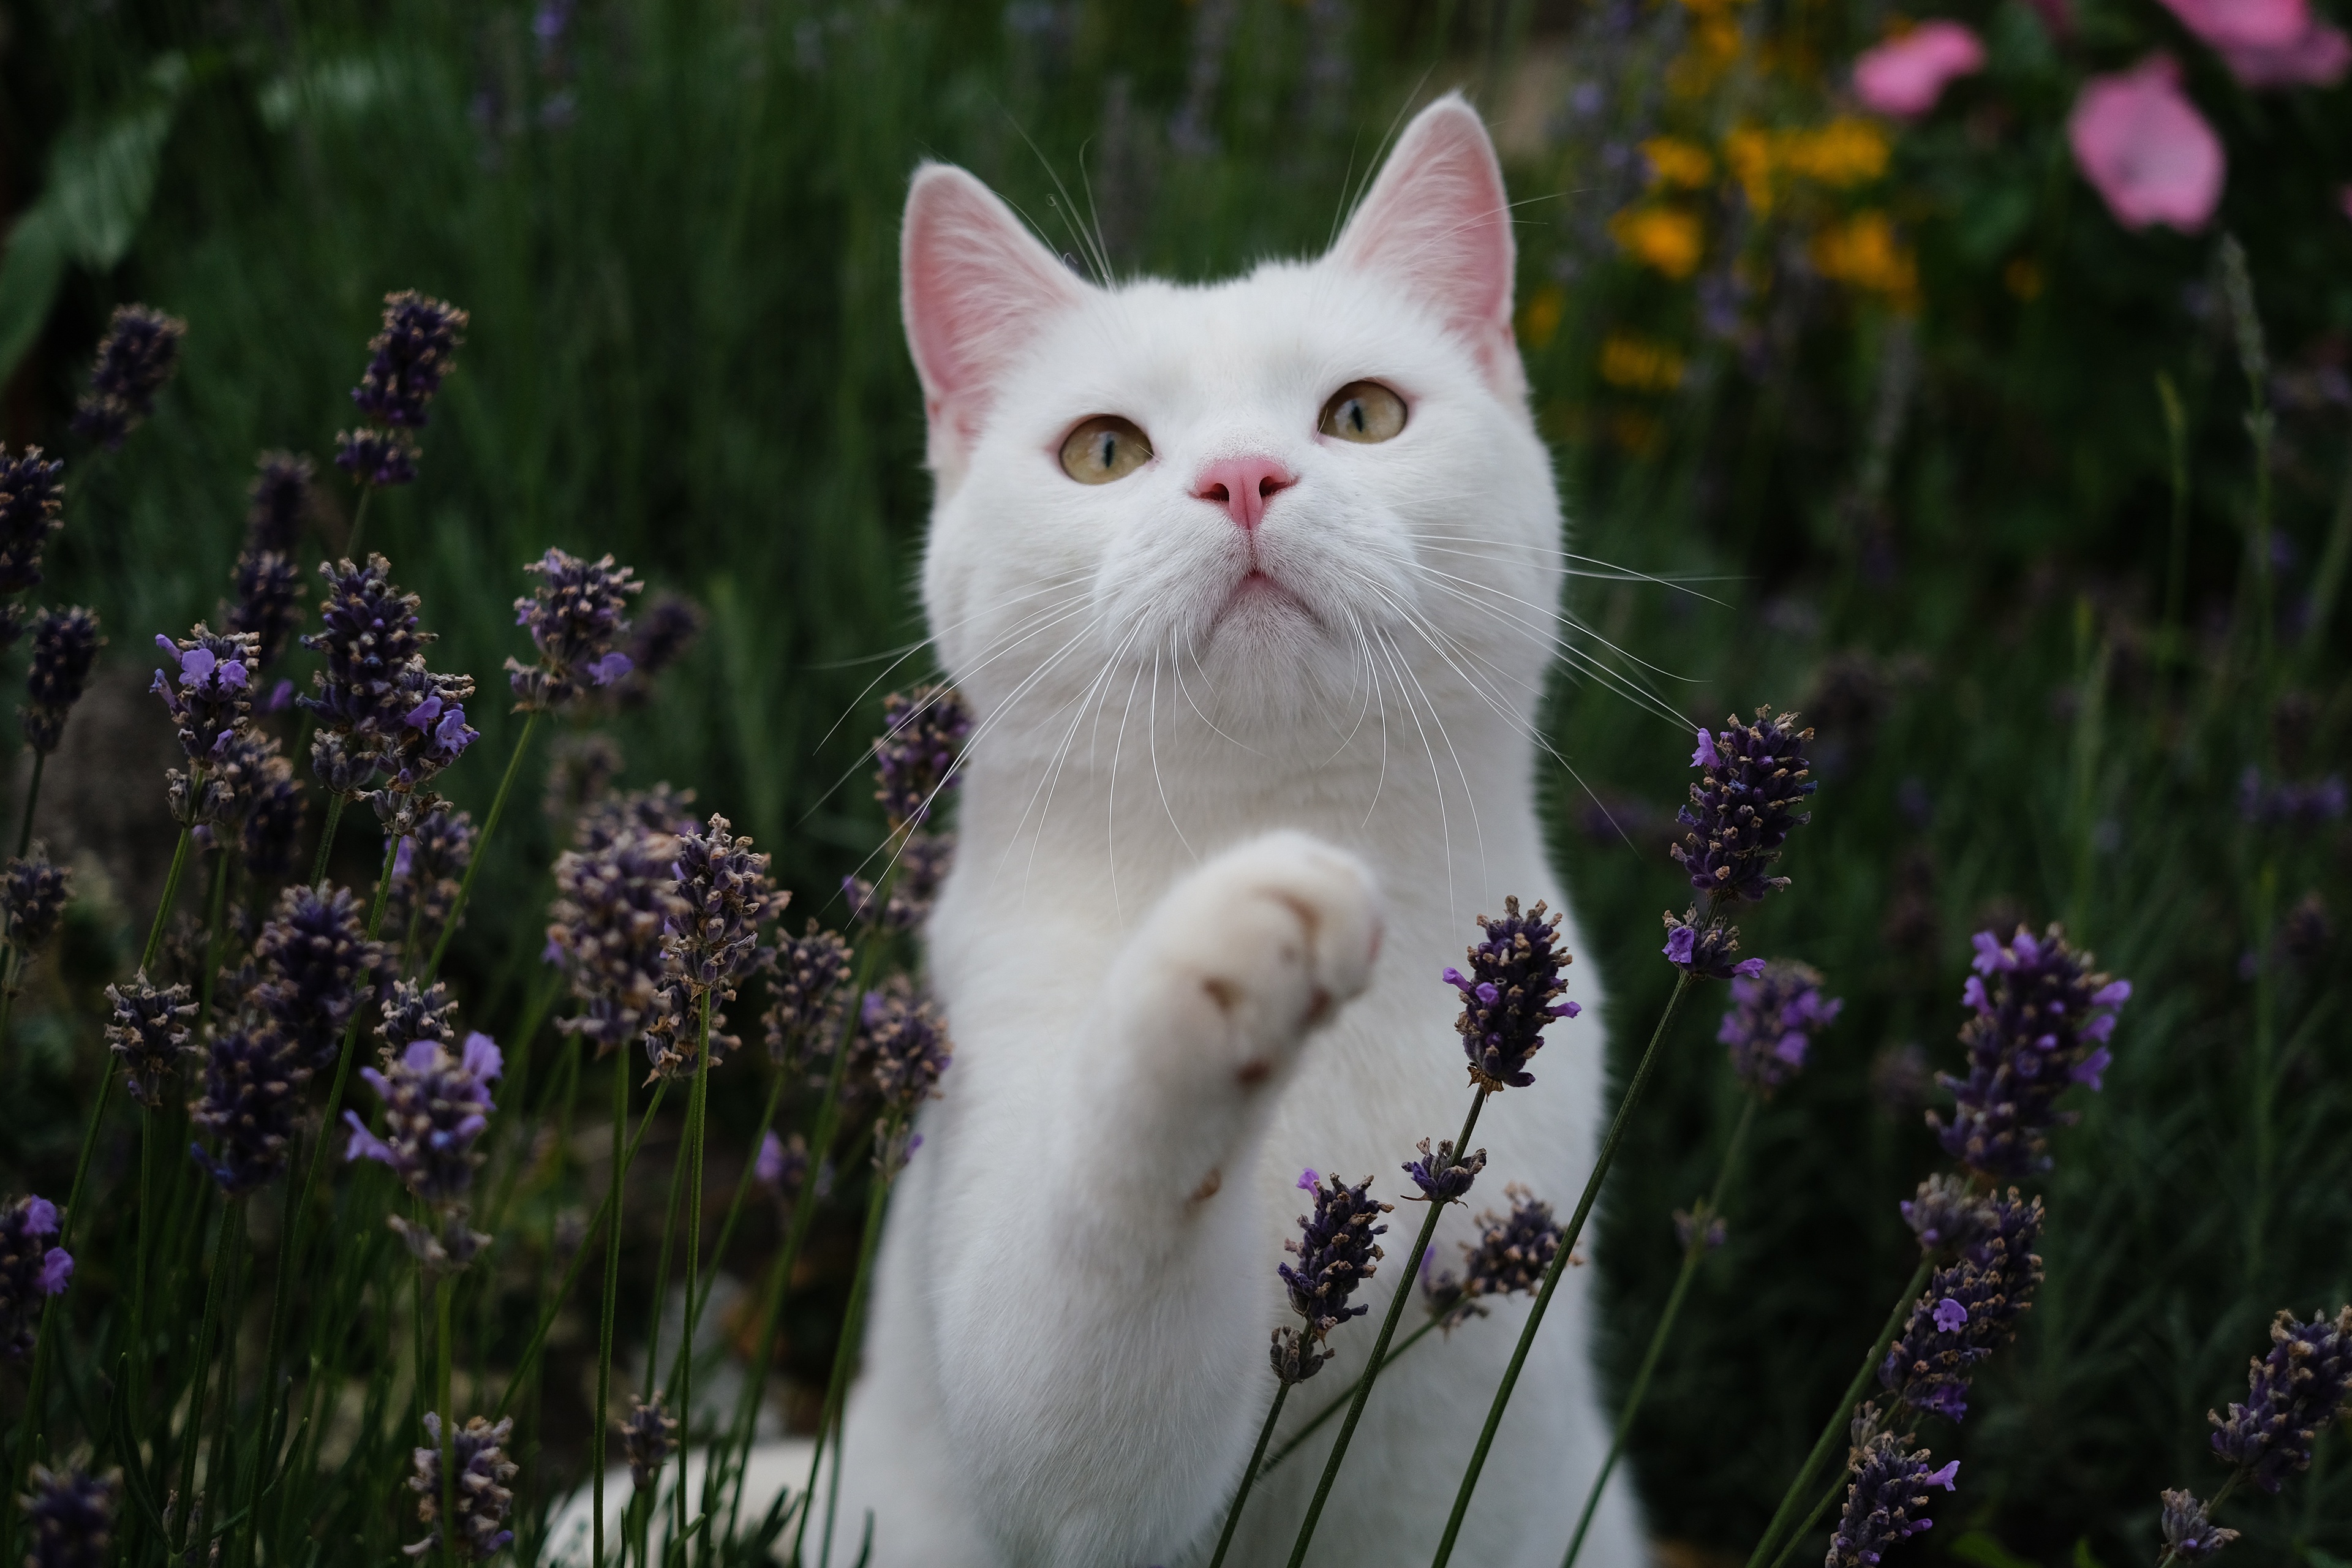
<box><xmin>548</xmin><ymin>818</ymin><xmax>689</xmax><ymax>1055</ymax></box>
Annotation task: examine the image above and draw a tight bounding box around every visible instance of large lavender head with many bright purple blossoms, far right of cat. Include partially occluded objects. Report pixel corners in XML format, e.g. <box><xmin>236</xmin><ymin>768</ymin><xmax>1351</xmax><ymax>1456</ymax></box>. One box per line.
<box><xmin>1929</xmin><ymin>926</ymin><xmax>2131</xmax><ymax>1180</ymax></box>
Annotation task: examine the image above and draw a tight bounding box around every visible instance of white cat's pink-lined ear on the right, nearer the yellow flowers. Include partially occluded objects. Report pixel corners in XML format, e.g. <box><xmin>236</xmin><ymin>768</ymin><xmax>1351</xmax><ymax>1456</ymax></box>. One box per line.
<box><xmin>1331</xmin><ymin>92</ymin><xmax>1524</xmax><ymax>398</ymax></box>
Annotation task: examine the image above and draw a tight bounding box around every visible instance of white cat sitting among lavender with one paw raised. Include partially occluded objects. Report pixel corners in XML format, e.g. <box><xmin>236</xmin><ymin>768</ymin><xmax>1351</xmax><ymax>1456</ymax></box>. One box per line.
<box><xmin>818</xmin><ymin>96</ymin><xmax>1642</xmax><ymax>1568</ymax></box>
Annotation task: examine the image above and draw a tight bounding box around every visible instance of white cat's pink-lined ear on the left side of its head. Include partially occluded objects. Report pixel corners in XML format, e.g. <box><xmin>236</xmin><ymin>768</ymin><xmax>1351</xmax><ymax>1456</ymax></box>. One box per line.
<box><xmin>899</xmin><ymin>162</ymin><xmax>1087</xmax><ymax>489</ymax></box>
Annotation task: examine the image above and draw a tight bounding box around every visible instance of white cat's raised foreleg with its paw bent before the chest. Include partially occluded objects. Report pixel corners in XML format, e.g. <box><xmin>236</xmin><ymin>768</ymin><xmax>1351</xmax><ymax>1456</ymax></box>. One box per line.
<box><xmin>941</xmin><ymin>832</ymin><xmax>1381</xmax><ymax>1568</ymax></box>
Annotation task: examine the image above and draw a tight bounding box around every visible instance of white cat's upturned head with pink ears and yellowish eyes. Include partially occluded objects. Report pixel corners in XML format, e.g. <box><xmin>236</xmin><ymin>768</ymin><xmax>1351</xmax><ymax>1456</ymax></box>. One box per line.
<box><xmin>903</xmin><ymin>96</ymin><xmax>1559</xmax><ymax>745</ymax></box>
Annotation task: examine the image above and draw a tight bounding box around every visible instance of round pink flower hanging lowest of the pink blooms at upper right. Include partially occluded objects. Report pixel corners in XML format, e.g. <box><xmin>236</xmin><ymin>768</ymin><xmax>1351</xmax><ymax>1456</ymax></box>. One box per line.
<box><xmin>2065</xmin><ymin>54</ymin><xmax>2227</xmax><ymax>233</ymax></box>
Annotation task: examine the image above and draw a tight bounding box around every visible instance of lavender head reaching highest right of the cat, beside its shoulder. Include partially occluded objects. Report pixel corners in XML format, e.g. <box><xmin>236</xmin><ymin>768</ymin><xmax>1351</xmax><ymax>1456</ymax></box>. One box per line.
<box><xmin>1672</xmin><ymin>707</ymin><xmax>1818</xmax><ymax>903</ymax></box>
